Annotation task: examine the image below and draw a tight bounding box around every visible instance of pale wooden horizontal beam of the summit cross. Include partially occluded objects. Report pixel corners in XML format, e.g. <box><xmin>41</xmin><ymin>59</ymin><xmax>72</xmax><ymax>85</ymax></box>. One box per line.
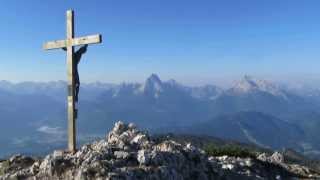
<box><xmin>43</xmin><ymin>34</ymin><xmax>102</xmax><ymax>50</ymax></box>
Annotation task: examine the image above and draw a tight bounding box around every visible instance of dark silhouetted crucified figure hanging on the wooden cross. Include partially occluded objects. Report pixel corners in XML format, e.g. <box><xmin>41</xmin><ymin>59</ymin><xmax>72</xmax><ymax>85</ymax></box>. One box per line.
<box><xmin>62</xmin><ymin>44</ymin><xmax>88</xmax><ymax>102</ymax></box>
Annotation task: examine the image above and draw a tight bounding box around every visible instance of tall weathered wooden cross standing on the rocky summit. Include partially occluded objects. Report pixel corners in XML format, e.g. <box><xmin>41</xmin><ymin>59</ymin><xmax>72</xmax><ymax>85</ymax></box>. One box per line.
<box><xmin>43</xmin><ymin>10</ymin><xmax>101</xmax><ymax>152</ymax></box>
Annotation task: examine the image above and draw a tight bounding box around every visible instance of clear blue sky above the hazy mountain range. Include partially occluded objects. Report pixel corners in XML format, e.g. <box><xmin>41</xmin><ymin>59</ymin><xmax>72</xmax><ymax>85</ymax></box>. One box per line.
<box><xmin>0</xmin><ymin>0</ymin><xmax>320</xmax><ymax>84</ymax></box>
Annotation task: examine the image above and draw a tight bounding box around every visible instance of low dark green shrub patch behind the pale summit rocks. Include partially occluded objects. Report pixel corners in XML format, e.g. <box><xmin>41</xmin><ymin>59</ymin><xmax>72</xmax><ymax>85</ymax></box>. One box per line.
<box><xmin>204</xmin><ymin>144</ymin><xmax>256</xmax><ymax>158</ymax></box>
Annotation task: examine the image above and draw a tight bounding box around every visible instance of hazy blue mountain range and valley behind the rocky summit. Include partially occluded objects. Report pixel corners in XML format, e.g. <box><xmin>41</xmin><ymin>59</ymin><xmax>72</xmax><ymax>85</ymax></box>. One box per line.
<box><xmin>0</xmin><ymin>74</ymin><xmax>320</xmax><ymax>157</ymax></box>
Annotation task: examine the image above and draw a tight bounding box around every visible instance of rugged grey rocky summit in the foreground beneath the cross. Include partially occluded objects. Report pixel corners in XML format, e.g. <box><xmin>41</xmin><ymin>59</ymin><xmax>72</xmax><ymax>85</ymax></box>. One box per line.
<box><xmin>0</xmin><ymin>121</ymin><xmax>320</xmax><ymax>180</ymax></box>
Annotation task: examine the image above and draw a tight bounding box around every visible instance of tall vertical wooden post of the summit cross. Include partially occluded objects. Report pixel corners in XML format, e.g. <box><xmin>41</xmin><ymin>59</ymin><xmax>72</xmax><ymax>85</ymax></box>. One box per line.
<box><xmin>66</xmin><ymin>10</ymin><xmax>77</xmax><ymax>152</ymax></box>
